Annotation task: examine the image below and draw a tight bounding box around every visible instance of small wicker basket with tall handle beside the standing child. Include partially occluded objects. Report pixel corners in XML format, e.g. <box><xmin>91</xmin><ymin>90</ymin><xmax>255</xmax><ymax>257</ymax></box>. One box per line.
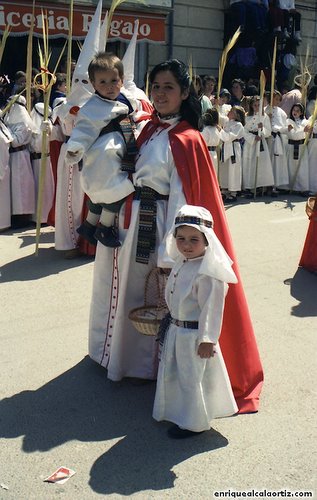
<box><xmin>129</xmin><ymin>267</ymin><xmax>168</xmax><ymax>336</ymax></box>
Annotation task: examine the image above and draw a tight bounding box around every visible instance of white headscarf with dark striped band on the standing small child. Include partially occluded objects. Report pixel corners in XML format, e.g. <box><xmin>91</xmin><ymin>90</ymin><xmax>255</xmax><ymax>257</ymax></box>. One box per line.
<box><xmin>166</xmin><ymin>205</ymin><xmax>238</xmax><ymax>283</ymax></box>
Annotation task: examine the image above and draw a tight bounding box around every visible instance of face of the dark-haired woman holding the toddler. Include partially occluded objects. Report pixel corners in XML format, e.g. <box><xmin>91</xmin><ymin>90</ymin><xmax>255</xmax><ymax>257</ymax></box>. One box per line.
<box><xmin>151</xmin><ymin>71</ymin><xmax>188</xmax><ymax>117</ymax></box>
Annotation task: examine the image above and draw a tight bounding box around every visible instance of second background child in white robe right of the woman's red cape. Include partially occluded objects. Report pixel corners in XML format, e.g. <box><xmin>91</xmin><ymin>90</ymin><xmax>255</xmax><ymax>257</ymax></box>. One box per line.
<box><xmin>219</xmin><ymin>106</ymin><xmax>245</xmax><ymax>202</ymax></box>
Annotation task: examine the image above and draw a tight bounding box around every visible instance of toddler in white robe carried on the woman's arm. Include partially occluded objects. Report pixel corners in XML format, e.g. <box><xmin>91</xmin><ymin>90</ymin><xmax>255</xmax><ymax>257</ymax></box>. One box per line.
<box><xmin>66</xmin><ymin>52</ymin><xmax>148</xmax><ymax>248</ymax></box>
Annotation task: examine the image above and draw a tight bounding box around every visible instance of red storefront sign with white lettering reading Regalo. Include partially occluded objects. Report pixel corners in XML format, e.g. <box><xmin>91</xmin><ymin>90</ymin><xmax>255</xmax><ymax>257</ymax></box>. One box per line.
<box><xmin>0</xmin><ymin>1</ymin><xmax>165</xmax><ymax>43</ymax></box>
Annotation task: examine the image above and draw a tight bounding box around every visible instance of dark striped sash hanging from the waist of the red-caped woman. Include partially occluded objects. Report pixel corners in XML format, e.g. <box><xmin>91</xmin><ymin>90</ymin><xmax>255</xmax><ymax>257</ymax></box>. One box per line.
<box><xmin>134</xmin><ymin>186</ymin><xmax>168</xmax><ymax>264</ymax></box>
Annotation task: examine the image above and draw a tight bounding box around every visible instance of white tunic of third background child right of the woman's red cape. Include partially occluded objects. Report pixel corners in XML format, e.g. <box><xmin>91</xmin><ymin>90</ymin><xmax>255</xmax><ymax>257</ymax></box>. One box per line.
<box><xmin>242</xmin><ymin>113</ymin><xmax>274</xmax><ymax>189</ymax></box>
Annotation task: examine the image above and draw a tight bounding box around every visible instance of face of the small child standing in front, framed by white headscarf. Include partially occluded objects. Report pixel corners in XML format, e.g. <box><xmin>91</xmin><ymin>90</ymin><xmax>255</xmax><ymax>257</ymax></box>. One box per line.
<box><xmin>176</xmin><ymin>226</ymin><xmax>206</xmax><ymax>259</ymax></box>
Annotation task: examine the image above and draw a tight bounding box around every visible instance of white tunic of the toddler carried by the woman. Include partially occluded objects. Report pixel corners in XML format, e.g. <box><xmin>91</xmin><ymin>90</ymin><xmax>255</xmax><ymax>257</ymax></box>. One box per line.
<box><xmin>66</xmin><ymin>94</ymin><xmax>137</xmax><ymax>203</ymax></box>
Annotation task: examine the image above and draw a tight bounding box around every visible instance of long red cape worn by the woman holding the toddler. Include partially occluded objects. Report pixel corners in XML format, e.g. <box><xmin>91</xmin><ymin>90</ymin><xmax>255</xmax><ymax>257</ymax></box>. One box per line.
<box><xmin>139</xmin><ymin>121</ymin><xmax>263</xmax><ymax>413</ymax></box>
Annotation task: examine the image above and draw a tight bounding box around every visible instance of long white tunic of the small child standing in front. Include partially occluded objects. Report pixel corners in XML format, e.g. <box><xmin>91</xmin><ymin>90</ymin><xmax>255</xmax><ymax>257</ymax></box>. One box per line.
<box><xmin>153</xmin><ymin>257</ymin><xmax>238</xmax><ymax>432</ymax></box>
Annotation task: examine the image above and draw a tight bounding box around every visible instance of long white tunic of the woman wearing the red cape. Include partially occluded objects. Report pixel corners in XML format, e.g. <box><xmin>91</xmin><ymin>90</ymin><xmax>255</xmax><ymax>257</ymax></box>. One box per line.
<box><xmin>89</xmin><ymin>119</ymin><xmax>185</xmax><ymax>380</ymax></box>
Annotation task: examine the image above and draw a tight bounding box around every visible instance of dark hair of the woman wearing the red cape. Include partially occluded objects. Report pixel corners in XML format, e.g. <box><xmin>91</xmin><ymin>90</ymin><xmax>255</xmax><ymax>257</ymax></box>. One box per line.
<box><xmin>149</xmin><ymin>59</ymin><xmax>202</xmax><ymax>130</ymax></box>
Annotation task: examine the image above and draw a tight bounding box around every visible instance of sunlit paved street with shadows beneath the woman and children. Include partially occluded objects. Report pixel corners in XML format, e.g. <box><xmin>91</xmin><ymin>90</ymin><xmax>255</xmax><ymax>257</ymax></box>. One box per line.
<box><xmin>0</xmin><ymin>196</ymin><xmax>317</xmax><ymax>500</ymax></box>
